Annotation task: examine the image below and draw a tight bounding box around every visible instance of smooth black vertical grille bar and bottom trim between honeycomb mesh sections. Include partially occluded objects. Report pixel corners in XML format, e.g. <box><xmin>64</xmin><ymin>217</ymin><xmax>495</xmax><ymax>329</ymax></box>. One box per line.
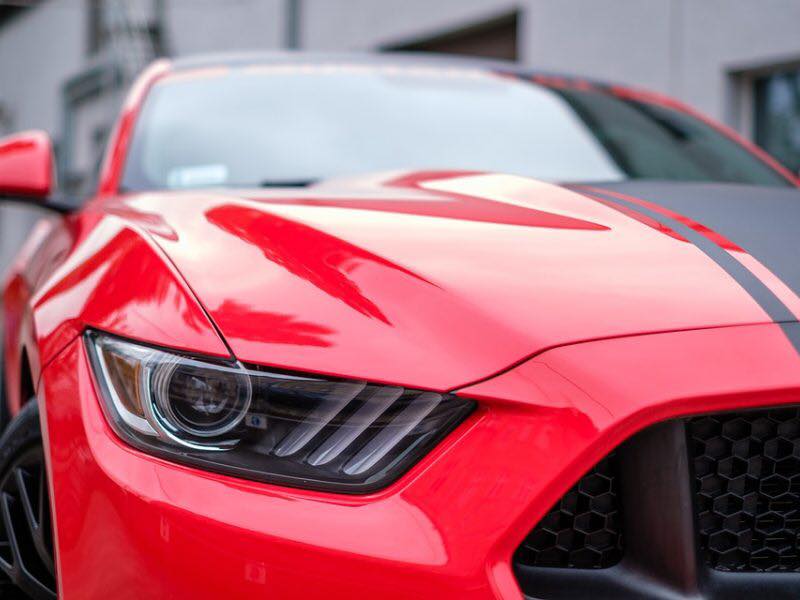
<box><xmin>514</xmin><ymin>418</ymin><xmax>800</xmax><ymax>600</ymax></box>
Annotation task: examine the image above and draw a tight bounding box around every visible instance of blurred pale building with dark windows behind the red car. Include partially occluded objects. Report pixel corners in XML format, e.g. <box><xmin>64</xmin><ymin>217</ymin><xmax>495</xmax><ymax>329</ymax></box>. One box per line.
<box><xmin>0</xmin><ymin>0</ymin><xmax>800</xmax><ymax>272</ymax></box>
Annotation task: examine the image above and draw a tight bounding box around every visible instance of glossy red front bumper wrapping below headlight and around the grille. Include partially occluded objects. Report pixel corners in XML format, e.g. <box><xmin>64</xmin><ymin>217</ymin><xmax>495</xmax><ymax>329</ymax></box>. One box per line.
<box><xmin>39</xmin><ymin>325</ymin><xmax>800</xmax><ymax>600</ymax></box>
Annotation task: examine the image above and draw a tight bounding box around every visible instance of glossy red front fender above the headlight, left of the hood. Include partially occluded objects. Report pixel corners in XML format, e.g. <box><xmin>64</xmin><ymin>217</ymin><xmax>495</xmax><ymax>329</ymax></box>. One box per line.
<box><xmin>4</xmin><ymin>211</ymin><xmax>230</xmax><ymax>414</ymax></box>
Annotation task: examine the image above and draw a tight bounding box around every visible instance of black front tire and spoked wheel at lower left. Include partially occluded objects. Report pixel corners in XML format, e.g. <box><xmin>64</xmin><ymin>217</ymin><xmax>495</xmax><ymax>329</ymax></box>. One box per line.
<box><xmin>0</xmin><ymin>399</ymin><xmax>57</xmax><ymax>600</ymax></box>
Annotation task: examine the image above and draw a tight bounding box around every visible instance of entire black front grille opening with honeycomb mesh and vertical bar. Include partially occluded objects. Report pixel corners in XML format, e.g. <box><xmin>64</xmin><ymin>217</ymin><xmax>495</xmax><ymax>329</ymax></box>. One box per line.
<box><xmin>513</xmin><ymin>406</ymin><xmax>800</xmax><ymax>600</ymax></box>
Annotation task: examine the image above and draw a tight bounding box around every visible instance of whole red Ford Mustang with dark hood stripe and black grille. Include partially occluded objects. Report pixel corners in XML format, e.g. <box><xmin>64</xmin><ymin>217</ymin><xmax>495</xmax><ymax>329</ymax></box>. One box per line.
<box><xmin>0</xmin><ymin>55</ymin><xmax>800</xmax><ymax>600</ymax></box>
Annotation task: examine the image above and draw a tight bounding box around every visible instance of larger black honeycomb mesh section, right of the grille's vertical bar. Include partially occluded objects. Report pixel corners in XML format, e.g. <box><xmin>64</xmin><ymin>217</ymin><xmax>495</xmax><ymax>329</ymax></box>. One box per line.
<box><xmin>688</xmin><ymin>407</ymin><xmax>800</xmax><ymax>572</ymax></box>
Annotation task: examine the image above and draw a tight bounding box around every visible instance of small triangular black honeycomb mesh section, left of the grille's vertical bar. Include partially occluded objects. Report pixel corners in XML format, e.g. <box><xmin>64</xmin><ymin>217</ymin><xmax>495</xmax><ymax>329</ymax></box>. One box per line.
<box><xmin>515</xmin><ymin>454</ymin><xmax>622</xmax><ymax>569</ymax></box>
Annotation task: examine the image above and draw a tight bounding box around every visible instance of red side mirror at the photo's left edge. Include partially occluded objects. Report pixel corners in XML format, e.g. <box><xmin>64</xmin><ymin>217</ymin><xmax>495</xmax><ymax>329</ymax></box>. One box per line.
<box><xmin>0</xmin><ymin>131</ymin><xmax>54</xmax><ymax>203</ymax></box>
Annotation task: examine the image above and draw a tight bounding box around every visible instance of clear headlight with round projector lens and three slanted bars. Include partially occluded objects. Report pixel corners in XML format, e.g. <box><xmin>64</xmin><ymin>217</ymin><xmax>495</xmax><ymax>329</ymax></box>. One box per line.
<box><xmin>85</xmin><ymin>331</ymin><xmax>474</xmax><ymax>493</ymax></box>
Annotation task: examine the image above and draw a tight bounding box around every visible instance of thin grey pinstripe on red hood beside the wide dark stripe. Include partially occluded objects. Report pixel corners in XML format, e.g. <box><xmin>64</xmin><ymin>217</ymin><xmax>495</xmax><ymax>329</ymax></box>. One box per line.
<box><xmin>573</xmin><ymin>188</ymin><xmax>800</xmax><ymax>353</ymax></box>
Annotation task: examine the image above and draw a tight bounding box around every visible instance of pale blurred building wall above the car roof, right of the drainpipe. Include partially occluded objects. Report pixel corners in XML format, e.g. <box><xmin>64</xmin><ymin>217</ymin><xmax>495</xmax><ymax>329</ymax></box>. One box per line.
<box><xmin>302</xmin><ymin>0</ymin><xmax>800</xmax><ymax>127</ymax></box>
